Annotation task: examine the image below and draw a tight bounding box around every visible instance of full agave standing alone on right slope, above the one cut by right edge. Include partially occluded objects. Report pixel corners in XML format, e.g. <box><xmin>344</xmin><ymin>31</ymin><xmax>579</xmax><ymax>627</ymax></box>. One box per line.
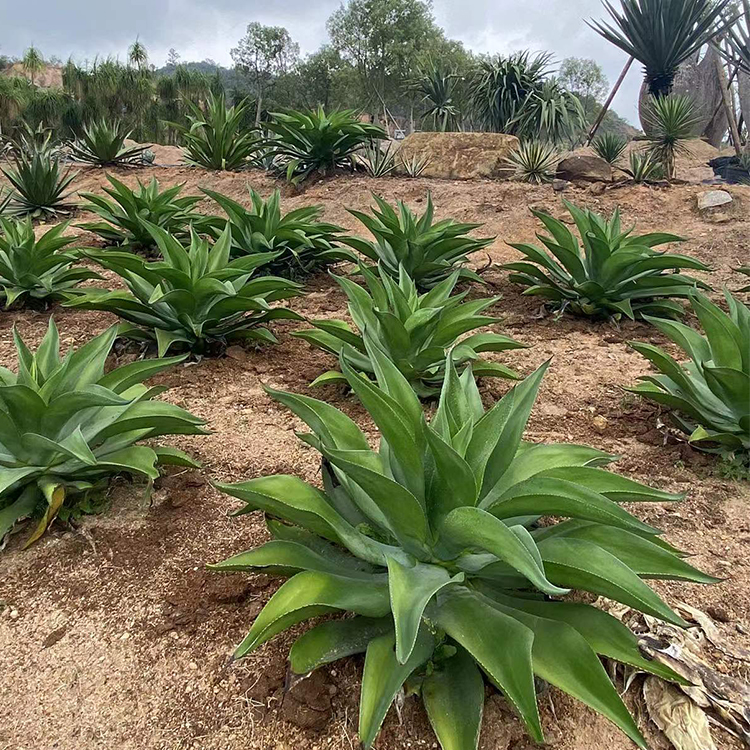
<box><xmin>503</xmin><ymin>200</ymin><xmax>711</xmax><ymax>320</ymax></box>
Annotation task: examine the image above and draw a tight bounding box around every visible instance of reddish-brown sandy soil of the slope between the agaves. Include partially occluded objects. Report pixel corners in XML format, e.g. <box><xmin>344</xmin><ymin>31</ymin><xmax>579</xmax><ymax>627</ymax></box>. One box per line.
<box><xmin>0</xmin><ymin>168</ymin><xmax>750</xmax><ymax>750</ymax></box>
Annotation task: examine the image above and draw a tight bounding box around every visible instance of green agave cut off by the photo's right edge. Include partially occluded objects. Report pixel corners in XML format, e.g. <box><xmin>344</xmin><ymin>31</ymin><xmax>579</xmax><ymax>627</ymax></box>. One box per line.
<box><xmin>630</xmin><ymin>292</ymin><xmax>750</xmax><ymax>457</ymax></box>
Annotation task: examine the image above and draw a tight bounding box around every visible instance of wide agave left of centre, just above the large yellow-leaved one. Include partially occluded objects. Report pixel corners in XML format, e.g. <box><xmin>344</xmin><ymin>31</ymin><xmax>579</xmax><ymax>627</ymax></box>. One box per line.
<box><xmin>65</xmin><ymin>224</ymin><xmax>301</xmax><ymax>357</ymax></box>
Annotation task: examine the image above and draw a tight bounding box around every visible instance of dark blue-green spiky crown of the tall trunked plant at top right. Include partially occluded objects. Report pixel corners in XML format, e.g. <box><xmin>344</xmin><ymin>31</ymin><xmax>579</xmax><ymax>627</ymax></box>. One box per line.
<box><xmin>588</xmin><ymin>0</ymin><xmax>730</xmax><ymax>97</ymax></box>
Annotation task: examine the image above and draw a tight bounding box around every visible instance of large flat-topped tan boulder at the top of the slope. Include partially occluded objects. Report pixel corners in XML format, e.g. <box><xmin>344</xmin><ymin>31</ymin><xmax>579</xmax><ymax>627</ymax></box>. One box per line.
<box><xmin>398</xmin><ymin>133</ymin><xmax>520</xmax><ymax>180</ymax></box>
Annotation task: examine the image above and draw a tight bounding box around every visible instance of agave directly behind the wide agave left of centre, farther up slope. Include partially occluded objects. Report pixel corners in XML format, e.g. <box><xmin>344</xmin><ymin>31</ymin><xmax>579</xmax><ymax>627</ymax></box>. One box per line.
<box><xmin>78</xmin><ymin>175</ymin><xmax>205</xmax><ymax>250</ymax></box>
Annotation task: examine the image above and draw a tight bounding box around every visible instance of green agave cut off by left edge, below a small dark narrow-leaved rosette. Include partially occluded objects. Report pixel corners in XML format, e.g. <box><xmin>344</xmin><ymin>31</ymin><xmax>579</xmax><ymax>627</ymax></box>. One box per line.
<box><xmin>0</xmin><ymin>218</ymin><xmax>101</xmax><ymax>307</ymax></box>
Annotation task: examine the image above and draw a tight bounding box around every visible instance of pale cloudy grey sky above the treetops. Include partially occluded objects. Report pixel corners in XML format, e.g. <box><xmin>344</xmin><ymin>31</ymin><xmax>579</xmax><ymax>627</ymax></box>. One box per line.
<box><xmin>0</xmin><ymin>0</ymin><xmax>640</xmax><ymax>122</ymax></box>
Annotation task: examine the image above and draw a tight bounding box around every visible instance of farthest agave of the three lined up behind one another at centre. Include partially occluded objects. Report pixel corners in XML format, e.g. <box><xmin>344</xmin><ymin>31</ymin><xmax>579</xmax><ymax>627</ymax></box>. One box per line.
<box><xmin>341</xmin><ymin>193</ymin><xmax>494</xmax><ymax>289</ymax></box>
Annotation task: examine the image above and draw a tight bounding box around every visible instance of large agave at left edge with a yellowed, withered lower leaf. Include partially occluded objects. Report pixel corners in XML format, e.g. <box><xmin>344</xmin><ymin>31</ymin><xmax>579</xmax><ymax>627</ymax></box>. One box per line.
<box><xmin>0</xmin><ymin>319</ymin><xmax>205</xmax><ymax>546</ymax></box>
